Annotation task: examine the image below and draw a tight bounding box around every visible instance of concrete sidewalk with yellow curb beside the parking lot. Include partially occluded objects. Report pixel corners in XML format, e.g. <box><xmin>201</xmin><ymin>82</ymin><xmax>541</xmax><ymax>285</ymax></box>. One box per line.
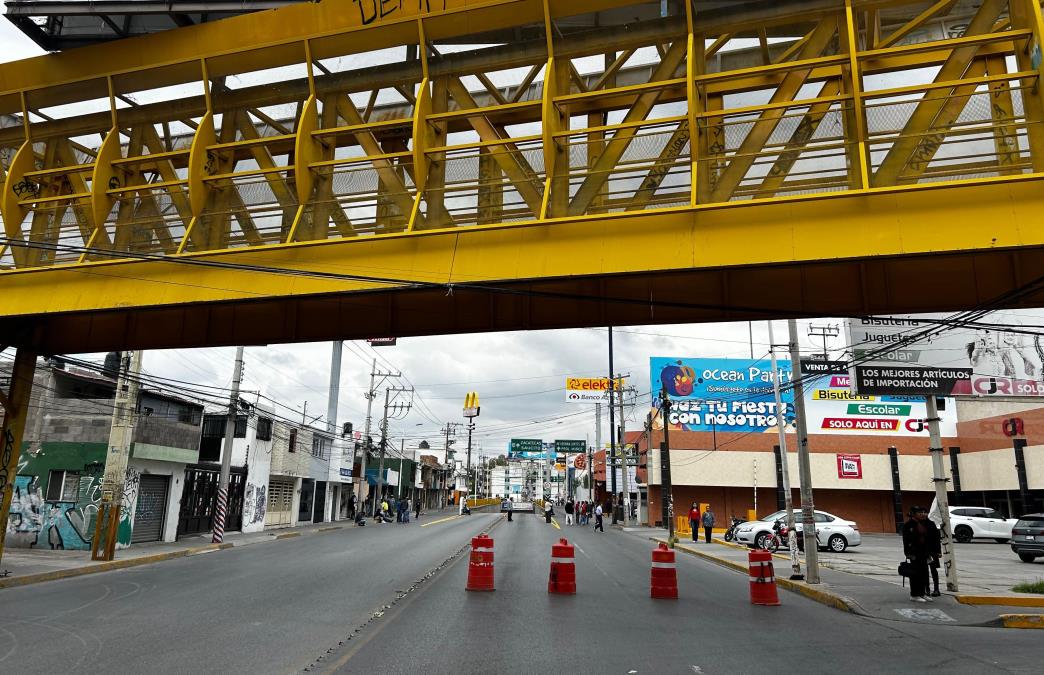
<box><xmin>626</xmin><ymin>528</ymin><xmax>1044</xmax><ymax>628</ymax></box>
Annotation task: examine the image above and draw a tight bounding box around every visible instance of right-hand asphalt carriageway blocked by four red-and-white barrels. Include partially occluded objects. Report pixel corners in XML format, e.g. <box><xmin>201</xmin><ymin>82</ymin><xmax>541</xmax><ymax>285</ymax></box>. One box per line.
<box><xmin>318</xmin><ymin>515</ymin><xmax>1041</xmax><ymax>674</ymax></box>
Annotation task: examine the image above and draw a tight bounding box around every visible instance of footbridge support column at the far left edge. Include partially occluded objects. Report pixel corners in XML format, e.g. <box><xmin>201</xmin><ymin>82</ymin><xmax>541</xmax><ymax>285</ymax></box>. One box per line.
<box><xmin>0</xmin><ymin>347</ymin><xmax>37</xmax><ymax>562</ymax></box>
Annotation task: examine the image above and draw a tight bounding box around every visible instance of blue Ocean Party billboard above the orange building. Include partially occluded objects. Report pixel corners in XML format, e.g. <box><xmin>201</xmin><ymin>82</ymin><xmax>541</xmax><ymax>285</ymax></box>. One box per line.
<box><xmin>649</xmin><ymin>357</ymin><xmax>793</xmax><ymax>432</ymax></box>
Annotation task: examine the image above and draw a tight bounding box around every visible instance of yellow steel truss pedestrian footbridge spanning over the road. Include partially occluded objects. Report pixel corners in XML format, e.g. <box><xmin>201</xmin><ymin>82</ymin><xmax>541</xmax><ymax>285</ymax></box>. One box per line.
<box><xmin>0</xmin><ymin>0</ymin><xmax>1044</xmax><ymax>352</ymax></box>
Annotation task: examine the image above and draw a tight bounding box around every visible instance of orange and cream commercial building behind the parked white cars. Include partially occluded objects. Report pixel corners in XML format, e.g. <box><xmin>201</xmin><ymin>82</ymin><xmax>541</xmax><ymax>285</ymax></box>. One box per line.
<box><xmin>628</xmin><ymin>397</ymin><xmax>1044</xmax><ymax>532</ymax></box>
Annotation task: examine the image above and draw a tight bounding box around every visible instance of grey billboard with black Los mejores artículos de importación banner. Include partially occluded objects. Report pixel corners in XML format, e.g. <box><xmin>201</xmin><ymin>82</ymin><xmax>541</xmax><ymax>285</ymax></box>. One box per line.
<box><xmin>847</xmin><ymin>312</ymin><xmax>1044</xmax><ymax>396</ymax></box>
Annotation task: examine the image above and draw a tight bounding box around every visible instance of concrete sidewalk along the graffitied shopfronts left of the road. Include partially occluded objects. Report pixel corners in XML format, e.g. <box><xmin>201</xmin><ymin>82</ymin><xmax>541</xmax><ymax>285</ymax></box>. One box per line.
<box><xmin>0</xmin><ymin>506</ymin><xmax>456</xmax><ymax>588</ymax></box>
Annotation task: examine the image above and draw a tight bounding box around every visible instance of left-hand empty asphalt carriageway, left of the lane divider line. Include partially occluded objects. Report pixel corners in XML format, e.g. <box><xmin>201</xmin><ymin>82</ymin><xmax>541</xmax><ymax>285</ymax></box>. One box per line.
<box><xmin>0</xmin><ymin>511</ymin><xmax>499</xmax><ymax>674</ymax></box>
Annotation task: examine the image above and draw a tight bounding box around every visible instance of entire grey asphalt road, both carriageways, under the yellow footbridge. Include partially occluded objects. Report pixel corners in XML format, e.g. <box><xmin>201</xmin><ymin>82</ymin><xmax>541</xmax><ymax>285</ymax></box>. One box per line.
<box><xmin>0</xmin><ymin>512</ymin><xmax>1041</xmax><ymax>675</ymax></box>
